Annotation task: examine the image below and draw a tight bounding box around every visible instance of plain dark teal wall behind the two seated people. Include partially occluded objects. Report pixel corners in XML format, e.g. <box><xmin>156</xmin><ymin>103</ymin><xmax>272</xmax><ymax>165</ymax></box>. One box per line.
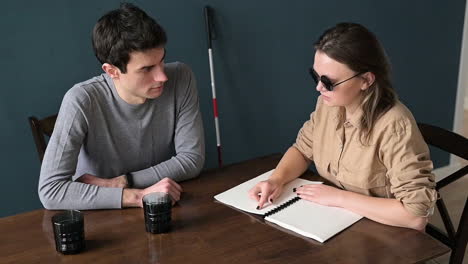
<box><xmin>0</xmin><ymin>0</ymin><xmax>465</xmax><ymax>217</ymax></box>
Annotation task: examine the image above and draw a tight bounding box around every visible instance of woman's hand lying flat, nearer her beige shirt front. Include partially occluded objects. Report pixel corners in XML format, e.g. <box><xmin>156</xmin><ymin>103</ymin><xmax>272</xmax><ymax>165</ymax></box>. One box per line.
<box><xmin>296</xmin><ymin>184</ymin><xmax>344</xmax><ymax>207</ymax></box>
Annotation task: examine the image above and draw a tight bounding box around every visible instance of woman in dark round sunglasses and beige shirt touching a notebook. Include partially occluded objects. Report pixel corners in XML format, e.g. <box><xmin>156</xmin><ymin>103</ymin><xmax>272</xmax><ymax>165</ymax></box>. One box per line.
<box><xmin>249</xmin><ymin>23</ymin><xmax>437</xmax><ymax>230</ymax></box>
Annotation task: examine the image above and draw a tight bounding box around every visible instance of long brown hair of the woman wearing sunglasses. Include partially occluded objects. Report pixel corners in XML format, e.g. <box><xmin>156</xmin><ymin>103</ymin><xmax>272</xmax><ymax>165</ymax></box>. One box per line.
<box><xmin>314</xmin><ymin>23</ymin><xmax>397</xmax><ymax>144</ymax></box>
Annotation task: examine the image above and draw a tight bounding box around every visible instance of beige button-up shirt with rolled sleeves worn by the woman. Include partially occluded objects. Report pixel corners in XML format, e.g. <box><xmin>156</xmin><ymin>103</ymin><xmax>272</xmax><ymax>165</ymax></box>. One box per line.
<box><xmin>293</xmin><ymin>97</ymin><xmax>437</xmax><ymax>216</ymax></box>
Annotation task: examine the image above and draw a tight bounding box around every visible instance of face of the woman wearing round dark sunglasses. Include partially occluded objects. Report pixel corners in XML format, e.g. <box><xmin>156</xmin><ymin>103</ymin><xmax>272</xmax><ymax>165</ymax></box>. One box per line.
<box><xmin>313</xmin><ymin>50</ymin><xmax>368</xmax><ymax>107</ymax></box>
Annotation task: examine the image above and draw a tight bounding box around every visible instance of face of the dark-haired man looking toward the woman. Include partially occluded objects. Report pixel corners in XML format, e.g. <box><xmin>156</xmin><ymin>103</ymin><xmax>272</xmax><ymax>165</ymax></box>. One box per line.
<box><xmin>114</xmin><ymin>47</ymin><xmax>167</xmax><ymax>104</ymax></box>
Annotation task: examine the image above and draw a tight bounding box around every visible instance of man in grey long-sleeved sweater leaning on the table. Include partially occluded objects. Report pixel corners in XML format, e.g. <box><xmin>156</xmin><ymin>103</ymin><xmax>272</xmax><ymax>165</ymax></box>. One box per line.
<box><xmin>38</xmin><ymin>1</ymin><xmax>205</xmax><ymax>209</ymax></box>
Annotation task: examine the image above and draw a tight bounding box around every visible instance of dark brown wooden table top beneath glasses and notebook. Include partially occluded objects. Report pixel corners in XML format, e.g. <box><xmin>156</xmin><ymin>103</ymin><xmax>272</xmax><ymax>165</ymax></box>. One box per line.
<box><xmin>0</xmin><ymin>155</ymin><xmax>449</xmax><ymax>264</ymax></box>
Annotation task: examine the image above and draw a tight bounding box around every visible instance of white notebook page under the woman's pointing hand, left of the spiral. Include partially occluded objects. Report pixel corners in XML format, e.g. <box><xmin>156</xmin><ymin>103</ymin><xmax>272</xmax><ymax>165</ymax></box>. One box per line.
<box><xmin>214</xmin><ymin>169</ymin><xmax>321</xmax><ymax>214</ymax></box>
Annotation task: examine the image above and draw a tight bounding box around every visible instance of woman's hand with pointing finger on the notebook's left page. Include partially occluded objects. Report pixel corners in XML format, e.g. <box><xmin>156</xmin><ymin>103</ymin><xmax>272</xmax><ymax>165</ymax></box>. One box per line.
<box><xmin>249</xmin><ymin>179</ymin><xmax>283</xmax><ymax>209</ymax></box>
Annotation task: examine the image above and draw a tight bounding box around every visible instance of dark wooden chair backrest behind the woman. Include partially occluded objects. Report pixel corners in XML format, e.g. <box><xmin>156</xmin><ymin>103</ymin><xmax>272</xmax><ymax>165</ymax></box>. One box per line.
<box><xmin>418</xmin><ymin>123</ymin><xmax>468</xmax><ymax>264</ymax></box>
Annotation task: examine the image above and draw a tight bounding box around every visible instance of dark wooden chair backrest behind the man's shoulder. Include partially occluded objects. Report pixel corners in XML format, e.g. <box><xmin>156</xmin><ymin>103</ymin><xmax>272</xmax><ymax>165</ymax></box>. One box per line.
<box><xmin>28</xmin><ymin>115</ymin><xmax>57</xmax><ymax>162</ymax></box>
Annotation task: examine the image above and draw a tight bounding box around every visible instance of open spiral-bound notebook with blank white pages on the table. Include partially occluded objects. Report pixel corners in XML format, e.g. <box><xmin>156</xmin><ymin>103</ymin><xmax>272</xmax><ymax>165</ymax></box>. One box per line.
<box><xmin>214</xmin><ymin>170</ymin><xmax>362</xmax><ymax>243</ymax></box>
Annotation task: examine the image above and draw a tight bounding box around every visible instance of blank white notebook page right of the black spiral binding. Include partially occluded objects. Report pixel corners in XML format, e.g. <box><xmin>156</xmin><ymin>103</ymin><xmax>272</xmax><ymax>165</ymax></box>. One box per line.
<box><xmin>265</xmin><ymin>199</ymin><xmax>362</xmax><ymax>243</ymax></box>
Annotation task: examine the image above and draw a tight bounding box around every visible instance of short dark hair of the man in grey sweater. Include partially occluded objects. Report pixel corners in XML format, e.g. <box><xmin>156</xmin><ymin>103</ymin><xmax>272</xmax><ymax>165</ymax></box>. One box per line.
<box><xmin>92</xmin><ymin>3</ymin><xmax>167</xmax><ymax>73</ymax></box>
